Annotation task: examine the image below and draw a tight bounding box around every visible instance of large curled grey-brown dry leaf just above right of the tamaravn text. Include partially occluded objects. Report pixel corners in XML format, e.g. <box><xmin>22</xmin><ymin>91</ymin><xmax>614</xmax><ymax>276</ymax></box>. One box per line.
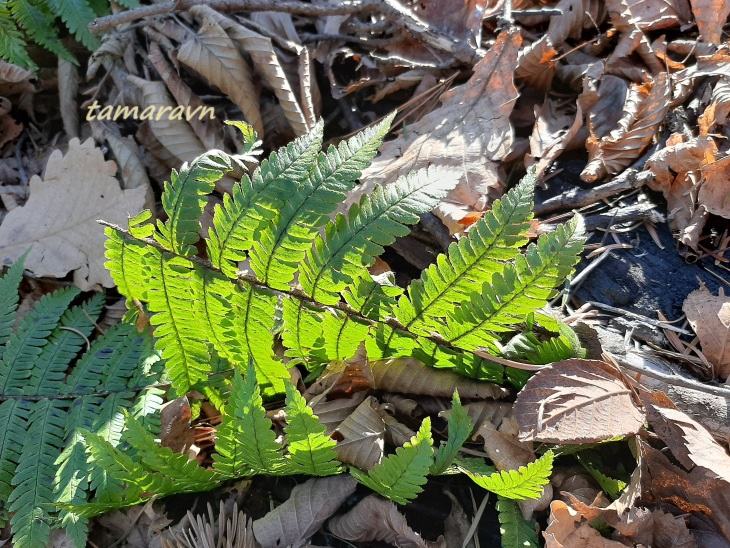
<box><xmin>182</xmin><ymin>6</ymin><xmax>264</xmax><ymax>138</ymax></box>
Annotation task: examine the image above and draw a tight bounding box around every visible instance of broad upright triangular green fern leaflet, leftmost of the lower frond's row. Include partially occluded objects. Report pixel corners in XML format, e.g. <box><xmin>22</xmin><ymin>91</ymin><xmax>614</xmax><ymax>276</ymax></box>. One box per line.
<box><xmin>213</xmin><ymin>365</ymin><xmax>284</xmax><ymax>477</ymax></box>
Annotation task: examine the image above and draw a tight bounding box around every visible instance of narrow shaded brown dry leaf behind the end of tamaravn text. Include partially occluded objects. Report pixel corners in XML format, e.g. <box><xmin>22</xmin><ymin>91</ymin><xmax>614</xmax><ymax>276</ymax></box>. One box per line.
<box><xmin>147</xmin><ymin>42</ymin><xmax>223</xmax><ymax>150</ymax></box>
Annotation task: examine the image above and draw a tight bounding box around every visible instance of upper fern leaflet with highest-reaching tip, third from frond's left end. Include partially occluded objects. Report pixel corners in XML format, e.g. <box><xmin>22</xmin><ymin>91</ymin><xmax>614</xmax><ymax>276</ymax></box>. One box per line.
<box><xmin>250</xmin><ymin>115</ymin><xmax>393</xmax><ymax>289</ymax></box>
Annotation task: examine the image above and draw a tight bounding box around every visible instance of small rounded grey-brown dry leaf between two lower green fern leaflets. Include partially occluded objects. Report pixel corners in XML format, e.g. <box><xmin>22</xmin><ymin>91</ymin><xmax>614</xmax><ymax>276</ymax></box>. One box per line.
<box><xmin>334</xmin><ymin>396</ymin><xmax>385</xmax><ymax>470</ymax></box>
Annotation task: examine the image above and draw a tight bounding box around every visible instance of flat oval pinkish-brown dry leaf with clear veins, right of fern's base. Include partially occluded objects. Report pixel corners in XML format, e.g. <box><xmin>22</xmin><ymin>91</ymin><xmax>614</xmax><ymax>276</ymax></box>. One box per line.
<box><xmin>513</xmin><ymin>359</ymin><xmax>644</xmax><ymax>444</ymax></box>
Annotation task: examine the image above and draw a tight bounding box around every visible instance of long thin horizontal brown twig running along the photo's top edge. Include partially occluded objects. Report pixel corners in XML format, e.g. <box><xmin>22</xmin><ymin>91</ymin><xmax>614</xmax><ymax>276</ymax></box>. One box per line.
<box><xmin>89</xmin><ymin>0</ymin><xmax>381</xmax><ymax>34</ymax></box>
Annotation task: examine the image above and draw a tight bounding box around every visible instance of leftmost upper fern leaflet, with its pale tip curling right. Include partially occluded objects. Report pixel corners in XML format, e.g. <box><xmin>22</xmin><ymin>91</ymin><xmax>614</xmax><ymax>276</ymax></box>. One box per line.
<box><xmin>154</xmin><ymin>150</ymin><xmax>233</xmax><ymax>257</ymax></box>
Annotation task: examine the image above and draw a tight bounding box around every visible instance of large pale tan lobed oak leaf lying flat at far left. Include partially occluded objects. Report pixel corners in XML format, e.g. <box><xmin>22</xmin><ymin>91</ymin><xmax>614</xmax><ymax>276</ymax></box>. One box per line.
<box><xmin>0</xmin><ymin>139</ymin><xmax>147</xmax><ymax>291</ymax></box>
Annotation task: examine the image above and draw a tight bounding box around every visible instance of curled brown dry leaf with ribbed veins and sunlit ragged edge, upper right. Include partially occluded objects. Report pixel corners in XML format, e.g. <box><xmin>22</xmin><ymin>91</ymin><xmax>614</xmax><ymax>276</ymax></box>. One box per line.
<box><xmin>581</xmin><ymin>73</ymin><xmax>671</xmax><ymax>183</ymax></box>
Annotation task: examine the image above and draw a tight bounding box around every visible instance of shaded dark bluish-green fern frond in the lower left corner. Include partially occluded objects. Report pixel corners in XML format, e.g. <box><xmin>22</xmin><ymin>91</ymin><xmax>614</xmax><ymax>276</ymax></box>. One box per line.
<box><xmin>0</xmin><ymin>256</ymin><xmax>161</xmax><ymax>547</ymax></box>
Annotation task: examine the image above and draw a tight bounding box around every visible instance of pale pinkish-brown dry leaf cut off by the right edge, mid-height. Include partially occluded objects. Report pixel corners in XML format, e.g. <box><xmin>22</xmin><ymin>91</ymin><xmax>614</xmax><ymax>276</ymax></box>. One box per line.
<box><xmin>682</xmin><ymin>288</ymin><xmax>730</xmax><ymax>379</ymax></box>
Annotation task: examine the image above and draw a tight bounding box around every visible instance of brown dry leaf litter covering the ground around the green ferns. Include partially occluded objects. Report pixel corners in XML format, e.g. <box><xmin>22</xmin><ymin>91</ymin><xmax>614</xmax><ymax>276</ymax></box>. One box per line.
<box><xmin>0</xmin><ymin>0</ymin><xmax>730</xmax><ymax>546</ymax></box>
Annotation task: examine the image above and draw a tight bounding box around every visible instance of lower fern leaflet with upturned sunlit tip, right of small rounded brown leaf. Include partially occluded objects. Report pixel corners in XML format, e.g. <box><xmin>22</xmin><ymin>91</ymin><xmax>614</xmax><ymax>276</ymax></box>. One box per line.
<box><xmin>350</xmin><ymin>417</ymin><xmax>433</xmax><ymax>504</ymax></box>
